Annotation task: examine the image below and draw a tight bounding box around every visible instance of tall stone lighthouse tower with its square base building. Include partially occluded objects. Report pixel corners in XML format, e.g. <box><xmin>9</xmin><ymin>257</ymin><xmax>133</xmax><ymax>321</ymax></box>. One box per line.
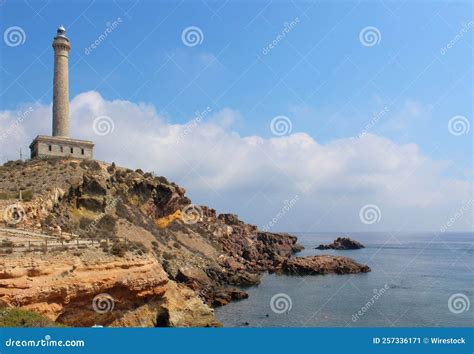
<box><xmin>30</xmin><ymin>25</ymin><xmax>94</xmax><ymax>159</ymax></box>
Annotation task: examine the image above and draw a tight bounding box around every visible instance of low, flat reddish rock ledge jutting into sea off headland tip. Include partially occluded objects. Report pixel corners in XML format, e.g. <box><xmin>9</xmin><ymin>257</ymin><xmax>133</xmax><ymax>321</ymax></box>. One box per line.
<box><xmin>281</xmin><ymin>256</ymin><xmax>370</xmax><ymax>275</ymax></box>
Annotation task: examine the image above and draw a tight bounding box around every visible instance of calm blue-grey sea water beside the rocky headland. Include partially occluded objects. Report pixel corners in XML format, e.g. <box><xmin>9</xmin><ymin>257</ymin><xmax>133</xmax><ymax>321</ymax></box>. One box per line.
<box><xmin>216</xmin><ymin>233</ymin><xmax>474</xmax><ymax>327</ymax></box>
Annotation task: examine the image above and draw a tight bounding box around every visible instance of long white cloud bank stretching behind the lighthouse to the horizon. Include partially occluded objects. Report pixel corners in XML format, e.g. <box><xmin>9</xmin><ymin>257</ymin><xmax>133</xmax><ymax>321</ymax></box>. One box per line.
<box><xmin>0</xmin><ymin>92</ymin><xmax>473</xmax><ymax>231</ymax></box>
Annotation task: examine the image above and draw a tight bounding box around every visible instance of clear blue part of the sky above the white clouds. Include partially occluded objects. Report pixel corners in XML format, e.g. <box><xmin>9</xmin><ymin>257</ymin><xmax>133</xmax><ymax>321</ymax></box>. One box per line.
<box><xmin>0</xmin><ymin>0</ymin><xmax>474</xmax><ymax>232</ymax></box>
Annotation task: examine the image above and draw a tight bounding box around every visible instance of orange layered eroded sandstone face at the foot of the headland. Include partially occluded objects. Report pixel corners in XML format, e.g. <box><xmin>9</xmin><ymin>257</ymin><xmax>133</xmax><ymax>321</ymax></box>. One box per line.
<box><xmin>0</xmin><ymin>250</ymin><xmax>220</xmax><ymax>327</ymax></box>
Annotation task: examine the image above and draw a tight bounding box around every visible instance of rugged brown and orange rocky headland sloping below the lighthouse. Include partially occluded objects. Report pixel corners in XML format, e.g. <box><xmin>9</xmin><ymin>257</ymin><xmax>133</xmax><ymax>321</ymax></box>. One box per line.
<box><xmin>0</xmin><ymin>159</ymin><xmax>301</xmax><ymax>326</ymax></box>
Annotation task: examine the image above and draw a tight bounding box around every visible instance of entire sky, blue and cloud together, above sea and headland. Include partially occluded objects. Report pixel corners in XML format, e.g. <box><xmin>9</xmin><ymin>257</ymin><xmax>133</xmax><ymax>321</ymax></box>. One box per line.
<box><xmin>0</xmin><ymin>0</ymin><xmax>474</xmax><ymax>232</ymax></box>
